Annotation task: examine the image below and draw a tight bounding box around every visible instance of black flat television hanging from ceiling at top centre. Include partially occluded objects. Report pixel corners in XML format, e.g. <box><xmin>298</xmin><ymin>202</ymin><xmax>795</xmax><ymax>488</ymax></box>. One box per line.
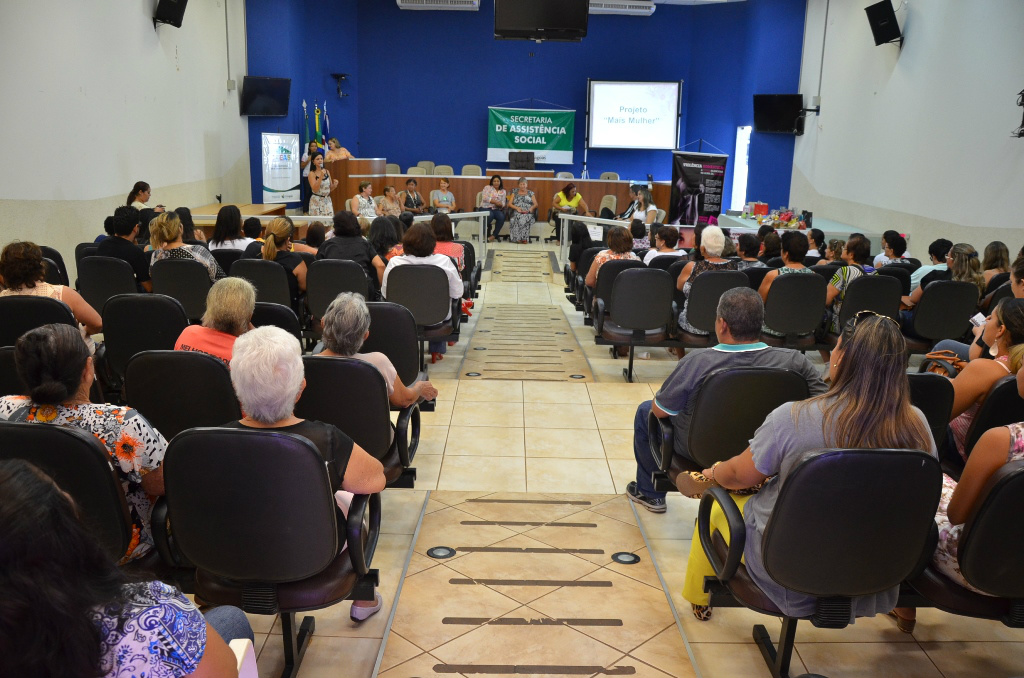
<box><xmin>495</xmin><ymin>0</ymin><xmax>590</xmax><ymax>41</ymax></box>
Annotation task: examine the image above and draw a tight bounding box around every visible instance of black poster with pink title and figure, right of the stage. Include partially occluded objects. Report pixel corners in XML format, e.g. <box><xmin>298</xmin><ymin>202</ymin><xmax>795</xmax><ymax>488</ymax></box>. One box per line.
<box><xmin>669</xmin><ymin>151</ymin><xmax>729</xmax><ymax>226</ymax></box>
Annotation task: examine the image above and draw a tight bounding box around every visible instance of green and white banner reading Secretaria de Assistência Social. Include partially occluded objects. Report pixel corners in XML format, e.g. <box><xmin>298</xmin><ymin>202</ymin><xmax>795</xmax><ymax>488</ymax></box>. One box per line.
<box><xmin>487</xmin><ymin>107</ymin><xmax>575</xmax><ymax>165</ymax></box>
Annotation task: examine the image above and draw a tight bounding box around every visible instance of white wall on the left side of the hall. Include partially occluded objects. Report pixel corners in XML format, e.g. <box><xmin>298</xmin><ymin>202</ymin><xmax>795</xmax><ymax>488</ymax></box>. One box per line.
<box><xmin>0</xmin><ymin>0</ymin><xmax>249</xmax><ymax>268</ymax></box>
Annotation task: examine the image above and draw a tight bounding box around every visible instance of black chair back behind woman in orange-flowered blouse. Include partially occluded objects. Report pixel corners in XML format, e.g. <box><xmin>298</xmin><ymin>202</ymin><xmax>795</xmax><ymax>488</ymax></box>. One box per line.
<box><xmin>0</xmin><ymin>421</ymin><xmax>132</xmax><ymax>561</ymax></box>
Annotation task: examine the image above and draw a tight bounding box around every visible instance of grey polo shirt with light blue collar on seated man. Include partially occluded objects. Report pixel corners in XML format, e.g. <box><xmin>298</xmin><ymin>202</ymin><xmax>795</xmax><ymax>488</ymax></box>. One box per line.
<box><xmin>654</xmin><ymin>342</ymin><xmax>827</xmax><ymax>458</ymax></box>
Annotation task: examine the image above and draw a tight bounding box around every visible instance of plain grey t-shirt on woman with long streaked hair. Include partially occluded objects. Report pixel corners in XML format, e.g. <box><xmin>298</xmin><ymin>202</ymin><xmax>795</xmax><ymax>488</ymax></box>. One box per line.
<box><xmin>743</xmin><ymin>400</ymin><xmax>936</xmax><ymax>623</ymax></box>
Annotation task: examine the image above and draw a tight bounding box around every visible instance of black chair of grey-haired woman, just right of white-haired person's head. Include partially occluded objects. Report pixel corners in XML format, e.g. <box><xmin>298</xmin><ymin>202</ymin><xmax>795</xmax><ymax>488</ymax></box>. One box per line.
<box><xmin>295</xmin><ymin>355</ymin><xmax>420</xmax><ymax>488</ymax></box>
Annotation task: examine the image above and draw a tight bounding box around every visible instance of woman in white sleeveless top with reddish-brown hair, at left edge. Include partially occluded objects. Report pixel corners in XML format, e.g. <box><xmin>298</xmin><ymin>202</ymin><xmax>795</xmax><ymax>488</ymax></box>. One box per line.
<box><xmin>0</xmin><ymin>240</ymin><xmax>103</xmax><ymax>336</ymax></box>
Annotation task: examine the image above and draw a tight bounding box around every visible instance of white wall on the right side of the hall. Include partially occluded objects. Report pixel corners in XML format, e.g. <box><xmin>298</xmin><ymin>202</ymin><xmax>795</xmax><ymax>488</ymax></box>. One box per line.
<box><xmin>790</xmin><ymin>0</ymin><xmax>1024</xmax><ymax>254</ymax></box>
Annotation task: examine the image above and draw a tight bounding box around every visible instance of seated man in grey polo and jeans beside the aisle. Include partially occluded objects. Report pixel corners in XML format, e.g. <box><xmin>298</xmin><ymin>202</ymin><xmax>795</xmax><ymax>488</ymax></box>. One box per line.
<box><xmin>626</xmin><ymin>287</ymin><xmax>825</xmax><ymax>513</ymax></box>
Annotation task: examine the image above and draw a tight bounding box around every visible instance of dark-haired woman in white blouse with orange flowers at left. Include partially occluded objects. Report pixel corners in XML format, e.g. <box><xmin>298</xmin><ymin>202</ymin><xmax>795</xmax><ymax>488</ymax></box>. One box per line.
<box><xmin>0</xmin><ymin>325</ymin><xmax>167</xmax><ymax>562</ymax></box>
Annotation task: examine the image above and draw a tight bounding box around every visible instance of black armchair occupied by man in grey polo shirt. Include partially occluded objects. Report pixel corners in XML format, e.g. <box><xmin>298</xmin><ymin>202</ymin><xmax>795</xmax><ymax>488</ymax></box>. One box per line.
<box><xmin>647</xmin><ymin>368</ymin><xmax>810</xmax><ymax>492</ymax></box>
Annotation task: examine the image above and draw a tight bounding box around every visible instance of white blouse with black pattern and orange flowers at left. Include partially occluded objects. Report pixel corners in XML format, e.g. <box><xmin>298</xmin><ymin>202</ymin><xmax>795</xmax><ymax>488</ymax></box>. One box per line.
<box><xmin>0</xmin><ymin>395</ymin><xmax>167</xmax><ymax>562</ymax></box>
